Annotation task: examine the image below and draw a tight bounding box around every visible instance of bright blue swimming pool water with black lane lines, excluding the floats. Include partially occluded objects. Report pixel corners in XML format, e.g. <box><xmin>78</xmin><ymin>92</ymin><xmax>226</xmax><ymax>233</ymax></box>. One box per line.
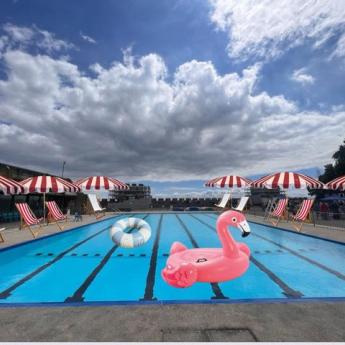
<box><xmin>0</xmin><ymin>212</ymin><xmax>345</xmax><ymax>306</ymax></box>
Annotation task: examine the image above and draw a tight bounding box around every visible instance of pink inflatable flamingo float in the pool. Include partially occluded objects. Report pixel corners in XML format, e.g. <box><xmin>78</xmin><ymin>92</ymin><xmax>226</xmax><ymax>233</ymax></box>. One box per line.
<box><xmin>162</xmin><ymin>211</ymin><xmax>250</xmax><ymax>288</ymax></box>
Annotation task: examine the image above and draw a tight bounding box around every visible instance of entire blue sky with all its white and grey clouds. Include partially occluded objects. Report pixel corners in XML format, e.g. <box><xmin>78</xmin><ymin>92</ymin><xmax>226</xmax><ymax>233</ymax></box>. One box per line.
<box><xmin>0</xmin><ymin>0</ymin><xmax>345</xmax><ymax>193</ymax></box>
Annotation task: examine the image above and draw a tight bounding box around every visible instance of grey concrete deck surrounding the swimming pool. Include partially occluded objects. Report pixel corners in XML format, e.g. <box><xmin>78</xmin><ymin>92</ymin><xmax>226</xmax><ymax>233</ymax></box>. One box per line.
<box><xmin>0</xmin><ymin>211</ymin><xmax>345</xmax><ymax>342</ymax></box>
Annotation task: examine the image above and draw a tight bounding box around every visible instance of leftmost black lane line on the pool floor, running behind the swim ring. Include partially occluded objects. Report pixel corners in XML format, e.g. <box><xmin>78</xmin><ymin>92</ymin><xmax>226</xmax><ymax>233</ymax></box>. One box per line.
<box><xmin>0</xmin><ymin>215</ymin><xmax>122</xmax><ymax>299</ymax></box>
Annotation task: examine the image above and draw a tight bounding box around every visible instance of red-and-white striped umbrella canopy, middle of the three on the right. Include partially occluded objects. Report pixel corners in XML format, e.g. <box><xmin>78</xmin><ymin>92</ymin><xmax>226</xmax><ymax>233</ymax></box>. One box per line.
<box><xmin>252</xmin><ymin>171</ymin><xmax>324</xmax><ymax>189</ymax></box>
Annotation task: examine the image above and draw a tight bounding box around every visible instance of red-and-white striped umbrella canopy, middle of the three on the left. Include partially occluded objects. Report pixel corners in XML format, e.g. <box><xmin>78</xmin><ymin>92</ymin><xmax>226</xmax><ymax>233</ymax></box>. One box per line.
<box><xmin>20</xmin><ymin>176</ymin><xmax>81</xmax><ymax>193</ymax></box>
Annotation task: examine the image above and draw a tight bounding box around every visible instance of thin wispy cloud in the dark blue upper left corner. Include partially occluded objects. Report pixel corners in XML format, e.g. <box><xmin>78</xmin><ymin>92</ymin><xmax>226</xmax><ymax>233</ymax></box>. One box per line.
<box><xmin>0</xmin><ymin>23</ymin><xmax>74</xmax><ymax>53</ymax></box>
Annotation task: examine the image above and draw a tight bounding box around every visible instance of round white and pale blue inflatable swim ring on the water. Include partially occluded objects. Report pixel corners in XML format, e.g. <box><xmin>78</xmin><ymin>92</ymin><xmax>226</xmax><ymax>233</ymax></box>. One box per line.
<box><xmin>110</xmin><ymin>218</ymin><xmax>151</xmax><ymax>248</ymax></box>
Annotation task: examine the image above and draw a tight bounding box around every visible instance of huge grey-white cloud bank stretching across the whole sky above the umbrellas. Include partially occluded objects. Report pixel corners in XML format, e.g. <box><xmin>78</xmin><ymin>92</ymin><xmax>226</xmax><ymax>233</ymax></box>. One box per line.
<box><xmin>0</xmin><ymin>50</ymin><xmax>345</xmax><ymax>180</ymax></box>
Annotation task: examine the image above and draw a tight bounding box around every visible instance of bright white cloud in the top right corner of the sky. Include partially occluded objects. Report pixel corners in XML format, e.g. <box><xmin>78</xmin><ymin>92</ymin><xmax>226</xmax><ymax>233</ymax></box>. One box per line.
<box><xmin>209</xmin><ymin>0</ymin><xmax>345</xmax><ymax>59</ymax></box>
